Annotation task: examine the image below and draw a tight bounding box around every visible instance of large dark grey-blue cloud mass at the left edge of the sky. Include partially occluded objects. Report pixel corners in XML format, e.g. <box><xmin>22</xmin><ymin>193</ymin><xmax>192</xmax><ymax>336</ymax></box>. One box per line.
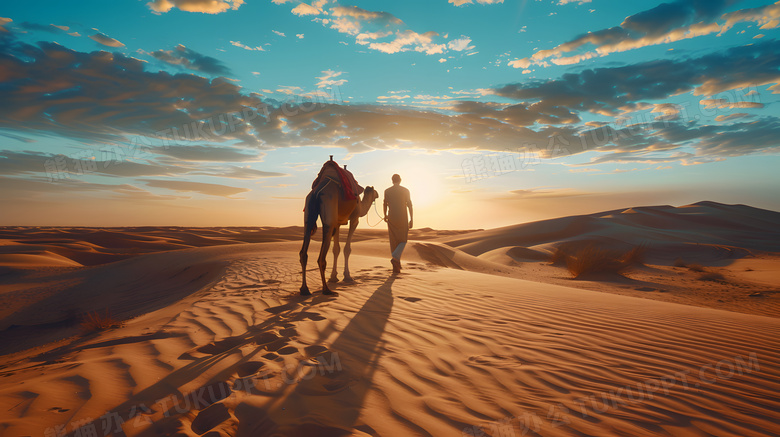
<box><xmin>0</xmin><ymin>34</ymin><xmax>263</xmax><ymax>144</ymax></box>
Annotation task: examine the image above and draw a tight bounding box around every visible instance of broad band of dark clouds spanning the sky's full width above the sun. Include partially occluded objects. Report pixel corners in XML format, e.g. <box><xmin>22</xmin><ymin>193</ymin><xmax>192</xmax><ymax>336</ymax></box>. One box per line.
<box><xmin>0</xmin><ymin>29</ymin><xmax>780</xmax><ymax>169</ymax></box>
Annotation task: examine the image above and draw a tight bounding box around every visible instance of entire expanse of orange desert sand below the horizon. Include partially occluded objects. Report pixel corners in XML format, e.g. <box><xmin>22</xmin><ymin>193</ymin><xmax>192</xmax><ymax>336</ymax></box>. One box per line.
<box><xmin>0</xmin><ymin>202</ymin><xmax>780</xmax><ymax>437</ymax></box>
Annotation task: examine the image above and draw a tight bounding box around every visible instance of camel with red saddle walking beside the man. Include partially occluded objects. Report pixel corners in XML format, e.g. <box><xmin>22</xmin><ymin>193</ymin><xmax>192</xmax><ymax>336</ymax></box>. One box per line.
<box><xmin>300</xmin><ymin>165</ymin><xmax>379</xmax><ymax>296</ymax></box>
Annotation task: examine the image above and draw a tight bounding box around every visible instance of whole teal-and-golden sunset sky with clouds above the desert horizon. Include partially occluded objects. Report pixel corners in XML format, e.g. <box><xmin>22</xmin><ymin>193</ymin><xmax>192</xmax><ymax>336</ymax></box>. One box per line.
<box><xmin>0</xmin><ymin>0</ymin><xmax>780</xmax><ymax>229</ymax></box>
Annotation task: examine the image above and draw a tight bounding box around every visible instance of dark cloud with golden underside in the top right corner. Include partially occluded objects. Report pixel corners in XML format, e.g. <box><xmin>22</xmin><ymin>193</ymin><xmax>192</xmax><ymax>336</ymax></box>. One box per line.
<box><xmin>510</xmin><ymin>0</ymin><xmax>780</xmax><ymax>68</ymax></box>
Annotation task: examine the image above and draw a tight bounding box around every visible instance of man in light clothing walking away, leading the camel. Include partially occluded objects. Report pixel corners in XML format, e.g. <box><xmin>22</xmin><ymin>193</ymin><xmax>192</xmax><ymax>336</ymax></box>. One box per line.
<box><xmin>384</xmin><ymin>174</ymin><xmax>414</xmax><ymax>273</ymax></box>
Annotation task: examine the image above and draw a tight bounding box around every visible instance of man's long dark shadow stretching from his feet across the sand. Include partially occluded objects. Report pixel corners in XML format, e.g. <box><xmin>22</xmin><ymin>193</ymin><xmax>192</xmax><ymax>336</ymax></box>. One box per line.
<box><xmin>235</xmin><ymin>276</ymin><xmax>395</xmax><ymax>437</ymax></box>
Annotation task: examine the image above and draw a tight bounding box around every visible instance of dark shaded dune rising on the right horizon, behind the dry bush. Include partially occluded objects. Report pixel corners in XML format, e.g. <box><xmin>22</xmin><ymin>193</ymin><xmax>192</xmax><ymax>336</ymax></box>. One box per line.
<box><xmin>441</xmin><ymin>202</ymin><xmax>780</xmax><ymax>265</ymax></box>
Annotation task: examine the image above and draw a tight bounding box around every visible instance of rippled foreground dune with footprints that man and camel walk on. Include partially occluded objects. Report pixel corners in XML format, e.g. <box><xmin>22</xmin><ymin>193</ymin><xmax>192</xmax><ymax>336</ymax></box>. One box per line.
<box><xmin>0</xmin><ymin>250</ymin><xmax>780</xmax><ymax>436</ymax></box>
